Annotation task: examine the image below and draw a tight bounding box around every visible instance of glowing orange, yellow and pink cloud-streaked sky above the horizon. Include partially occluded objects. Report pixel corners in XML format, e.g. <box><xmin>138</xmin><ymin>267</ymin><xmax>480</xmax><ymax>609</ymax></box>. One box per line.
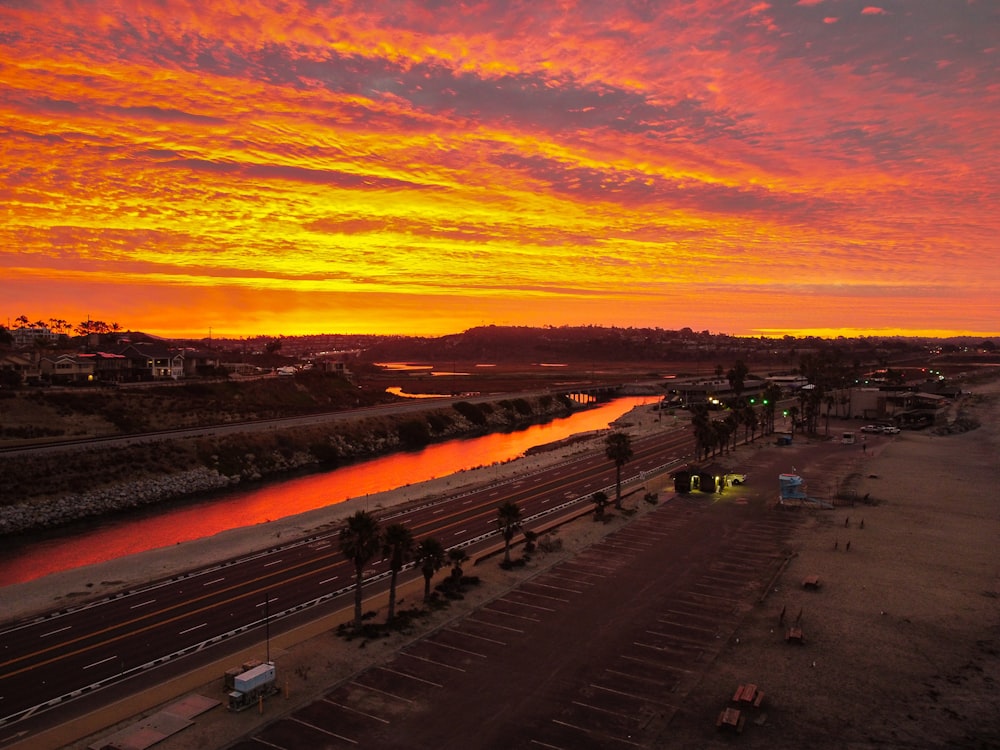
<box><xmin>0</xmin><ymin>0</ymin><xmax>1000</xmax><ymax>337</ymax></box>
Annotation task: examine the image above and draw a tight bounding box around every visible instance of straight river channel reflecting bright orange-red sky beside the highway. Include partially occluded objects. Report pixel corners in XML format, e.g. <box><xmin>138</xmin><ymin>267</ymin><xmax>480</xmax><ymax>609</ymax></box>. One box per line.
<box><xmin>0</xmin><ymin>398</ymin><xmax>652</xmax><ymax>586</ymax></box>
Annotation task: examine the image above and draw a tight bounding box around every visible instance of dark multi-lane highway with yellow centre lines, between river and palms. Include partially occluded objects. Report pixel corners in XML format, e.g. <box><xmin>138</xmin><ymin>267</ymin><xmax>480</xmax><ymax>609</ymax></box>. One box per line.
<box><xmin>0</xmin><ymin>426</ymin><xmax>691</xmax><ymax>745</ymax></box>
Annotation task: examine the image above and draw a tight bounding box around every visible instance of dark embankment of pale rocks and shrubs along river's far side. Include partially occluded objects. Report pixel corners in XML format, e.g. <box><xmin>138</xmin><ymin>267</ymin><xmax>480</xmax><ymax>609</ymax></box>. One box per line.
<box><xmin>0</xmin><ymin>397</ymin><xmax>572</xmax><ymax>536</ymax></box>
